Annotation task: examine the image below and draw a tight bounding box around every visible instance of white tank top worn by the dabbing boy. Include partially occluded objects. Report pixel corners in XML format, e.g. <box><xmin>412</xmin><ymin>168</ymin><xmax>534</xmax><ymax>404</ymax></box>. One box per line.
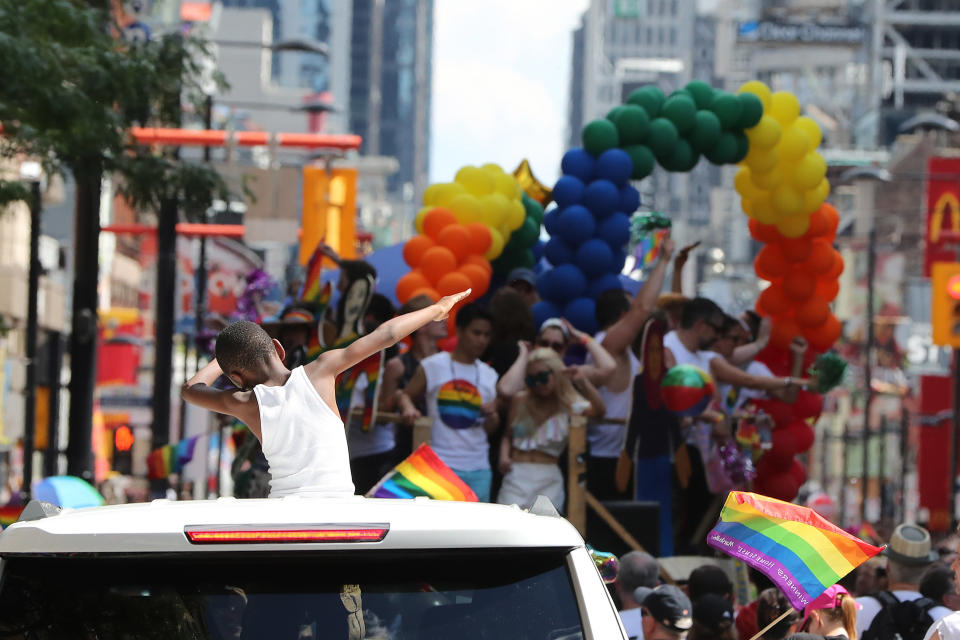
<box><xmin>253</xmin><ymin>367</ymin><xmax>354</xmax><ymax>498</ymax></box>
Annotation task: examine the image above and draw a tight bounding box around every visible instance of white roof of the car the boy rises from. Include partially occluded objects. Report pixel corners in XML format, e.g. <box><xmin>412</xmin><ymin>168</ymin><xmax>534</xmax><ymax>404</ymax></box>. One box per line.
<box><xmin>0</xmin><ymin>496</ymin><xmax>583</xmax><ymax>556</ymax></box>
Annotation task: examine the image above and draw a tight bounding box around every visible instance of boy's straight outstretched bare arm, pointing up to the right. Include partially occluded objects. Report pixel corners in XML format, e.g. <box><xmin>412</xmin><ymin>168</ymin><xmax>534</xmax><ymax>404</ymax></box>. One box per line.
<box><xmin>304</xmin><ymin>289</ymin><xmax>471</xmax><ymax>380</ymax></box>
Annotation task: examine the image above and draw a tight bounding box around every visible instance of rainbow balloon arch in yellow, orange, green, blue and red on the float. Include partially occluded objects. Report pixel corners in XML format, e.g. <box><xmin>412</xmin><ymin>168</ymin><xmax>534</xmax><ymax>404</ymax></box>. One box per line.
<box><xmin>396</xmin><ymin>81</ymin><xmax>844</xmax><ymax>499</ymax></box>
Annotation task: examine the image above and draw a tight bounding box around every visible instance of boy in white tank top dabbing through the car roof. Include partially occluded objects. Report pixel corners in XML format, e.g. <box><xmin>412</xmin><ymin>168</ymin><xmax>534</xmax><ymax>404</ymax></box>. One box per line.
<box><xmin>182</xmin><ymin>290</ymin><xmax>470</xmax><ymax>497</ymax></box>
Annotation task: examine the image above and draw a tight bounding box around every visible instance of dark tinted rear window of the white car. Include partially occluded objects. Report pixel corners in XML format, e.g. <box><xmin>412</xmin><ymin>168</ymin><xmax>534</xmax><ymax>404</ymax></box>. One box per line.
<box><xmin>0</xmin><ymin>550</ymin><xmax>583</xmax><ymax>640</ymax></box>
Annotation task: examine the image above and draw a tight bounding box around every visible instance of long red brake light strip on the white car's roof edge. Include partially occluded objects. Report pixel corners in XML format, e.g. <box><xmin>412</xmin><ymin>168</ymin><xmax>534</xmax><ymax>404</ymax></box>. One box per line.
<box><xmin>183</xmin><ymin>524</ymin><xmax>390</xmax><ymax>544</ymax></box>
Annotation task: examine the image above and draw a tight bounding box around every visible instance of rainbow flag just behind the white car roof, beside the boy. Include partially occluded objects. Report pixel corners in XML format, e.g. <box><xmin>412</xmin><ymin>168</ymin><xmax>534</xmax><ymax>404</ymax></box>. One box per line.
<box><xmin>367</xmin><ymin>444</ymin><xmax>479</xmax><ymax>502</ymax></box>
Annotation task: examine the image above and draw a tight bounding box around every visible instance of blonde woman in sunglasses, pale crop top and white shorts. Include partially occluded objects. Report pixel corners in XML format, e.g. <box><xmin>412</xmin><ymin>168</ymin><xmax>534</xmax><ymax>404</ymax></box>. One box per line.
<box><xmin>497</xmin><ymin>348</ymin><xmax>606</xmax><ymax>510</ymax></box>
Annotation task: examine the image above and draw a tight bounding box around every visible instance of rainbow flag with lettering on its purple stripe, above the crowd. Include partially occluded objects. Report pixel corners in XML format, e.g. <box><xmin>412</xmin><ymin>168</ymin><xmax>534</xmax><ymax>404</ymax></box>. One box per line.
<box><xmin>707</xmin><ymin>491</ymin><xmax>883</xmax><ymax>611</ymax></box>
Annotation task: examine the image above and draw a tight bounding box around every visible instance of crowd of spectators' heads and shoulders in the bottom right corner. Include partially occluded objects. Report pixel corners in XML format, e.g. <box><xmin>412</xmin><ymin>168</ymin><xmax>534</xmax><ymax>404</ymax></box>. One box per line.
<box><xmin>613</xmin><ymin>524</ymin><xmax>960</xmax><ymax>640</ymax></box>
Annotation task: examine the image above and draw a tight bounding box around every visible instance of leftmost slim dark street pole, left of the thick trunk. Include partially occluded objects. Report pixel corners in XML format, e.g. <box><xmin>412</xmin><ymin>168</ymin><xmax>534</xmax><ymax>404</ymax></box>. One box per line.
<box><xmin>22</xmin><ymin>180</ymin><xmax>41</xmax><ymax>500</ymax></box>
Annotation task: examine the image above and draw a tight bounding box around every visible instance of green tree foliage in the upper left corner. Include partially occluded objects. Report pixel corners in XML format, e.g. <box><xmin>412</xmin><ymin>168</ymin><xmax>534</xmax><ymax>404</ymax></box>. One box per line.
<box><xmin>0</xmin><ymin>0</ymin><xmax>228</xmax><ymax>215</ymax></box>
